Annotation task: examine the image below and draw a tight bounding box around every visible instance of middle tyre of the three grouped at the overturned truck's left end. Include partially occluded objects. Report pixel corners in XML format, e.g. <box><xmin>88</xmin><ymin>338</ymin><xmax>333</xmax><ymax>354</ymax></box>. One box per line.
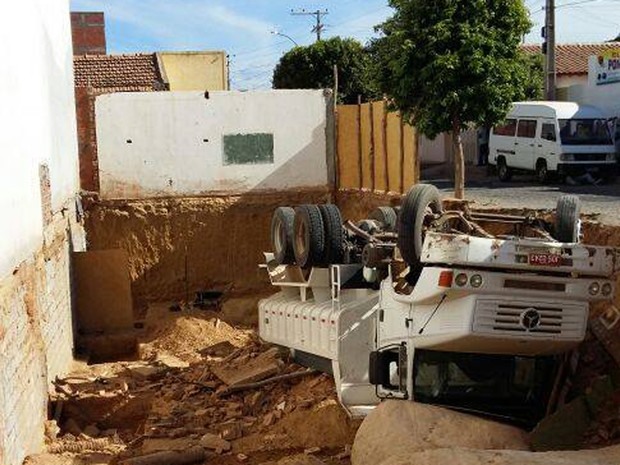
<box><xmin>293</xmin><ymin>205</ymin><xmax>325</xmax><ymax>268</ymax></box>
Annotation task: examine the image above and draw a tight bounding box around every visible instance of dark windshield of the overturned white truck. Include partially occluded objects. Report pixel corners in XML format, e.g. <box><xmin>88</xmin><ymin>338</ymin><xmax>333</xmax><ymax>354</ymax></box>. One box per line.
<box><xmin>413</xmin><ymin>349</ymin><xmax>556</xmax><ymax>427</ymax></box>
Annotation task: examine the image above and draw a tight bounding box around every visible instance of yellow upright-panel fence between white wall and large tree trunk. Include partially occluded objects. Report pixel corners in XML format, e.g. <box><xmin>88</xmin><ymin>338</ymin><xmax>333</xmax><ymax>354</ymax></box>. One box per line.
<box><xmin>337</xmin><ymin>101</ymin><xmax>420</xmax><ymax>193</ymax></box>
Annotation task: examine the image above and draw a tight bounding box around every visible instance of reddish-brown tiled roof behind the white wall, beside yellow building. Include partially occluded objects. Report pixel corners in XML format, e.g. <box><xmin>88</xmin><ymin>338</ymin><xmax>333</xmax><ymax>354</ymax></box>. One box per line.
<box><xmin>73</xmin><ymin>53</ymin><xmax>166</xmax><ymax>90</ymax></box>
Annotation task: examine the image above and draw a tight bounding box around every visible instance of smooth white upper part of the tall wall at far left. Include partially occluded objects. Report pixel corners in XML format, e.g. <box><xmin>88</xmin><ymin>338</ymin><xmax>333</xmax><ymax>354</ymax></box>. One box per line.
<box><xmin>0</xmin><ymin>0</ymin><xmax>78</xmax><ymax>276</ymax></box>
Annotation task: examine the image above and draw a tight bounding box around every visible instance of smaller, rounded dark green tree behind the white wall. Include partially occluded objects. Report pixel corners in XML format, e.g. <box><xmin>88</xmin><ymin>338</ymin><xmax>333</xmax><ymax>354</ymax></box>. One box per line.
<box><xmin>273</xmin><ymin>37</ymin><xmax>376</xmax><ymax>103</ymax></box>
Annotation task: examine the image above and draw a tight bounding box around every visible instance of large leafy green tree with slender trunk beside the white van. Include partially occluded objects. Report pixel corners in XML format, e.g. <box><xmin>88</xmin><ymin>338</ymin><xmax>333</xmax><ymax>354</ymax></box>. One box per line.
<box><xmin>372</xmin><ymin>0</ymin><xmax>531</xmax><ymax>198</ymax></box>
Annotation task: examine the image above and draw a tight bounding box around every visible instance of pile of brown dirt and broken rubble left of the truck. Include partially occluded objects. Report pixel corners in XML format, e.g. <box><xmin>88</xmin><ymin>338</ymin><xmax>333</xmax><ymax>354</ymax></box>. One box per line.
<box><xmin>26</xmin><ymin>304</ymin><xmax>358</xmax><ymax>465</ymax></box>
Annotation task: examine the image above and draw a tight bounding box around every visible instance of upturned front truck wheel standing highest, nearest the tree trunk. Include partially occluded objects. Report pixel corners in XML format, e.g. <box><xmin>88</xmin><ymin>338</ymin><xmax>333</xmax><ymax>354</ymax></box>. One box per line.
<box><xmin>398</xmin><ymin>184</ymin><xmax>443</xmax><ymax>268</ymax></box>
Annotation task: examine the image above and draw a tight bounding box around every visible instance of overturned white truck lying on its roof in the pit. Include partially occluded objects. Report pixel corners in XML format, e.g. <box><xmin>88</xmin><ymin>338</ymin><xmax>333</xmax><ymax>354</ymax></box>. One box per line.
<box><xmin>259</xmin><ymin>185</ymin><xmax>620</xmax><ymax>427</ymax></box>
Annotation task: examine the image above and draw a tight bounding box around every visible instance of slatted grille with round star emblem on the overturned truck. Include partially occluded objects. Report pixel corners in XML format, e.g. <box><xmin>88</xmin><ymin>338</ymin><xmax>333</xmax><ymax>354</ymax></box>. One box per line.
<box><xmin>473</xmin><ymin>300</ymin><xmax>588</xmax><ymax>339</ymax></box>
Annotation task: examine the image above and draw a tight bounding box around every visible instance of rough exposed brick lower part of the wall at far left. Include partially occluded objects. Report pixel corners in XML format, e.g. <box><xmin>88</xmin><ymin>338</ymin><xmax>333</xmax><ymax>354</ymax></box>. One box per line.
<box><xmin>0</xmin><ymin>200</ymin><xmax>84</xmax><ymax>465</ymax></box>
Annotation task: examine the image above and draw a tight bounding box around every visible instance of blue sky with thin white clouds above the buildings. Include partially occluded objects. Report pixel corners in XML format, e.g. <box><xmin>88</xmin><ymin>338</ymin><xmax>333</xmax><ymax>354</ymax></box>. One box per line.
<box><xmin>71</xmin><ymin>0</ymin><xmax>620</xmax><ymax>89</ymax></box>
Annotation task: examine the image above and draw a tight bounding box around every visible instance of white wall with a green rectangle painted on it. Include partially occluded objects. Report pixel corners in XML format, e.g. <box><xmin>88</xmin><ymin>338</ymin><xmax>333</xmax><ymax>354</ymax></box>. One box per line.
<box><xmin>95</xmin><ymin>90</ymin><xmax>330</xmax><ymax>199</ymax></box>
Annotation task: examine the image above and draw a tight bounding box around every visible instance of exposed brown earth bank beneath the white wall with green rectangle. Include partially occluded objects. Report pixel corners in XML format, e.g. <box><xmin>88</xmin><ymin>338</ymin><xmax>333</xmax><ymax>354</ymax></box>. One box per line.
<box><xmin>86</xmin><ymin>189</ymin><xmax>331</xmax><ymax>302</ymax></box>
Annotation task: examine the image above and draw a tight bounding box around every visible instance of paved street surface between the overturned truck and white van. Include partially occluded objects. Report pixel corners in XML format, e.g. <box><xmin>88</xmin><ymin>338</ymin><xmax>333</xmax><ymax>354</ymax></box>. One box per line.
<box><xmin>425</xmin><ymin>169</ymin><xmax>620</xmax><ymax>224</ymax></box>
